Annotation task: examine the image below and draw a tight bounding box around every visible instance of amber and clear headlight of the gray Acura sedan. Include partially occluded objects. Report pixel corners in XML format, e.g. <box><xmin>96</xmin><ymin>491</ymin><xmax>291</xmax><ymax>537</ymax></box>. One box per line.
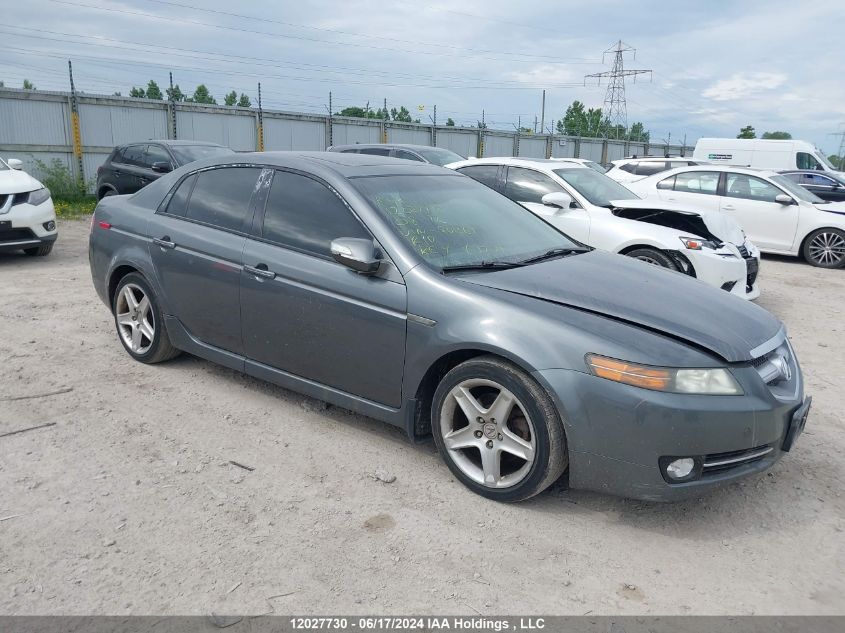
<box><xmin>587</xmin><ymin>354</ymin><xmax>743</xmax><ymax>396</ymax></box>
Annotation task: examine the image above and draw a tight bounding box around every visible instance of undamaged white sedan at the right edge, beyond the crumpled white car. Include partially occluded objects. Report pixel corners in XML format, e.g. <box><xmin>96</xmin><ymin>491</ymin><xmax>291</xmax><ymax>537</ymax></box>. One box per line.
<box><xmin>628</xmin><ymin>165</ymin><xmax>845</xmax><ymax>268</ymax></box>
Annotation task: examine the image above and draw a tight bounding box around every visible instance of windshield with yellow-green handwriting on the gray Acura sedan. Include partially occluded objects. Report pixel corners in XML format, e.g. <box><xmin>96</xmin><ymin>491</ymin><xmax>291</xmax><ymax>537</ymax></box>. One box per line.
<box><xmin>351</xmin><ymin>170</ymin><xmax>587</xmax><ymax>268</ymax></box>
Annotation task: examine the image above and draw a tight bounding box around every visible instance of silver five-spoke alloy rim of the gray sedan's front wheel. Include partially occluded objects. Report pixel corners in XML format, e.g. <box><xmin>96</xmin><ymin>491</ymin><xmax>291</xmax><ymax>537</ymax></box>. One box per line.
<box><xmin>440</xmin><ymin>378</ymin><xmax>537</xmax><ymax>488</ymax></box>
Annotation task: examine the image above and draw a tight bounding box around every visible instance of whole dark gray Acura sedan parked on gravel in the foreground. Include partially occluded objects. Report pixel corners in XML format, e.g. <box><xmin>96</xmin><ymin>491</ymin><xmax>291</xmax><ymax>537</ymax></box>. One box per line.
<box><xmin>89</xmin><ymin>152</ymin><xmax>810</xmax><ymax>501</ymax></box>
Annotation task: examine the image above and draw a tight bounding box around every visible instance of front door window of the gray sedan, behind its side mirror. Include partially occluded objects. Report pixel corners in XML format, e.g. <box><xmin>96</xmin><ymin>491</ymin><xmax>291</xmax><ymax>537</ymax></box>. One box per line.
<box><xmin>262</xmin><ymin>171</ymin><xmax>372</xmax><ymax>257</ymax></box>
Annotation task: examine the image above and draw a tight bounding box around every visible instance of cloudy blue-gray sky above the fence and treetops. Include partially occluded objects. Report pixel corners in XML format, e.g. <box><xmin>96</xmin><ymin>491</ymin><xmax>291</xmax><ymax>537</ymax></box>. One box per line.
<box><xmin>0</xmin><ymin>0</ymin><xmax>845</xmax><ymax>154</ymax></box>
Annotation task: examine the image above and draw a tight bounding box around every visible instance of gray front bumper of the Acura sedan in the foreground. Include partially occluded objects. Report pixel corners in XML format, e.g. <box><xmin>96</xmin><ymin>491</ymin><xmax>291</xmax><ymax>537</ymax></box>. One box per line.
<box><xmin>534</xmin><ymin>365</ymin><xmax>806</xmax><ymax>501</ymax></box>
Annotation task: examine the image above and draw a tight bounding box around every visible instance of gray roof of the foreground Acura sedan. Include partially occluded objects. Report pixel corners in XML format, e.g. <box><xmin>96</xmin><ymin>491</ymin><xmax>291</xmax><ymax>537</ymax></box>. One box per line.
<box><xmin>196</xmin><ymin>151</ymin><xmax>459</xmax><ymax>178</ymax></box>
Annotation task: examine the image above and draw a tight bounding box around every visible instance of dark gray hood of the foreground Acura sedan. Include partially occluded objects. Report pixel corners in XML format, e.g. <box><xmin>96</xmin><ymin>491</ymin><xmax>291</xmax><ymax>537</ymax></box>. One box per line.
<box><xmin>458</xmin><ymin>250</ymin><xmax>782</xmax><ymax>362</ymax></box>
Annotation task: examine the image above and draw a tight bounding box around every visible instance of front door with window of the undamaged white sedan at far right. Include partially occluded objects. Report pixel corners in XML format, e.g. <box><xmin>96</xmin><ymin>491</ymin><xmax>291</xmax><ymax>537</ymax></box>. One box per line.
<box><xmin>720</xmin><ymin>172</ymin><xmax>800</xmax><ymax>251</ymax></box>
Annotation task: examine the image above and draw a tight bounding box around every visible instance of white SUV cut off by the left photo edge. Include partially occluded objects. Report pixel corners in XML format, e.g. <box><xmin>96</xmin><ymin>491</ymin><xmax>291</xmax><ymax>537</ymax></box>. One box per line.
<box><xmin>0</xmin><ymin>158</ymin><xmax>58</xmax><ymax>256</ymax></box>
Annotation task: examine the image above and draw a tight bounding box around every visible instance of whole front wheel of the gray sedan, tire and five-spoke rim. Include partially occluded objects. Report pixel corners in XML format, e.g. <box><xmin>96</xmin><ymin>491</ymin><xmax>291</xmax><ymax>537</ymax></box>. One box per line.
<box><xmin>432</xmin><ymin>356</ymin><xmax>568</xmax><ymax>501</ymax></box>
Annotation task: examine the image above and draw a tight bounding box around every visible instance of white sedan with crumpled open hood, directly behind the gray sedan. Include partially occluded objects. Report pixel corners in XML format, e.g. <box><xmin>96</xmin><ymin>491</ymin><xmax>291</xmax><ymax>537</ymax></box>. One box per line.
<box><xmin>447</xmin><ymin>158</ymin><xmax>760</xmax><ymax>299</ymax></box>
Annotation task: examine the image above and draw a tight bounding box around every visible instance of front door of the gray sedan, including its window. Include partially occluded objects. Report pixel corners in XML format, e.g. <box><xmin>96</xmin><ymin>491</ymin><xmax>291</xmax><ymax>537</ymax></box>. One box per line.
<box><xmin>241</xmin><ymin>170</ymin><xmax>407</xmax><ymax>408</ymax></box>
